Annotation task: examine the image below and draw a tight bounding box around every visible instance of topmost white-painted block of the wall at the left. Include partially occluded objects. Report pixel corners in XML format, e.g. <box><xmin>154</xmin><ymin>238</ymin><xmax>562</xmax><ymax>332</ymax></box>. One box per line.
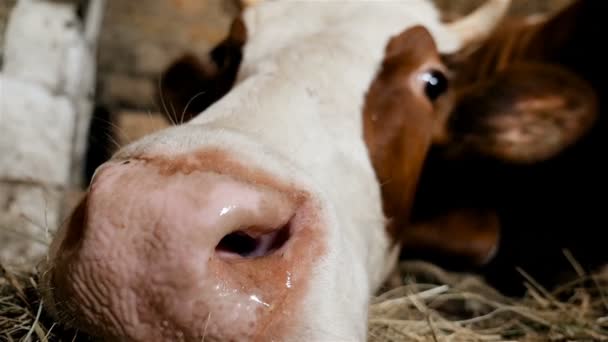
<box><xmin>3</xmin><ymin>0</ymin><xmax>85</xmax><ymax>93</ymax></box>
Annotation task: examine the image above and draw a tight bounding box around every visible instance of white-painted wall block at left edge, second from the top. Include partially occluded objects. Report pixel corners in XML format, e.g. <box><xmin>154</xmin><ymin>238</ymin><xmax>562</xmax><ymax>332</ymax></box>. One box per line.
<box><xmin>0</xmin><ymin>75</ymin><xmax>76</xmax><ymax>185</ymax></box>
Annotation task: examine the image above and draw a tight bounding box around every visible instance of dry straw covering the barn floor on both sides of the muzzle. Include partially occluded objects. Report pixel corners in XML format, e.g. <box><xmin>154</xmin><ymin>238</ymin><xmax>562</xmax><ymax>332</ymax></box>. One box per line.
<box><xmin>0</xmin><ymin>262</ymin><xmax>608</xmax><ymax>342</ymax></box>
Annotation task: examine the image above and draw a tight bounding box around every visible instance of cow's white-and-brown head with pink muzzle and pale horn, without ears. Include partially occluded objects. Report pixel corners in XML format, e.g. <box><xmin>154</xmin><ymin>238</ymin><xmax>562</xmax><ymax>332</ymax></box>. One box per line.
<box><xmin>35</xmin><ymin>0</ymin><xmax>592</xmax><ymax>341</ymax></box>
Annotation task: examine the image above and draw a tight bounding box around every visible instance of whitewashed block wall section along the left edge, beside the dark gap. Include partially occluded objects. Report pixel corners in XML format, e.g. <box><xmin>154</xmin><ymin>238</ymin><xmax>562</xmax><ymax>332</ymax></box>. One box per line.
<box><xmin>0</xmin><ymin>0</ymin><xmax>104</xmax><ymax>267</ymax></box>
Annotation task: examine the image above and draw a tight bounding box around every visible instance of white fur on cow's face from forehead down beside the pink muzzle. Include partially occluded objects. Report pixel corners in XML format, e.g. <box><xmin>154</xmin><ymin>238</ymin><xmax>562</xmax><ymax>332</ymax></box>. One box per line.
<box><xmin>119</xmin><ymin>0</ymin><xmax>470</xmax><ymax>341</ymax></box>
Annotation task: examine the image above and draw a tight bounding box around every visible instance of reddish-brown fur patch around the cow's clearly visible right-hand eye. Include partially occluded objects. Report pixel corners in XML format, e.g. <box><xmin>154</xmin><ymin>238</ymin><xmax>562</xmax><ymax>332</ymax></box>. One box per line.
<box><xmin>363</xmin><ymin>26</ymin><xmax>439</xmax><ymax>241</ymax></box>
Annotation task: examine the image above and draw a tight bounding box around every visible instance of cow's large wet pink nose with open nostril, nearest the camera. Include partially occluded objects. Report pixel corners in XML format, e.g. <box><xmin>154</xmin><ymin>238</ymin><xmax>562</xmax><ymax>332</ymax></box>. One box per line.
<box><xmin>46</xmin><ymin>160</ymin><xmax>314</xmax><ymax>341</ymax></box>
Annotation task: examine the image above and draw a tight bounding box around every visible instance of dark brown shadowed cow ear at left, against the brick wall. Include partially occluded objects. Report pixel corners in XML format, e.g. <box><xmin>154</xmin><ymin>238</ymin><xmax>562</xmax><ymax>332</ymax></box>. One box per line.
<box><xmin>157</xmin><ymin>18</ymin><xmax>247</xmax><ymax>123</ymax></box>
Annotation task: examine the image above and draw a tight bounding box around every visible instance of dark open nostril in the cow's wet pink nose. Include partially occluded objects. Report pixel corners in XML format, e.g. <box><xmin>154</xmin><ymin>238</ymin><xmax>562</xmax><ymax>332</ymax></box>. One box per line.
<box><xmin>215</xmin><ymin>223</ymin><xmax>291</xmax><ymax>258</ymax></box>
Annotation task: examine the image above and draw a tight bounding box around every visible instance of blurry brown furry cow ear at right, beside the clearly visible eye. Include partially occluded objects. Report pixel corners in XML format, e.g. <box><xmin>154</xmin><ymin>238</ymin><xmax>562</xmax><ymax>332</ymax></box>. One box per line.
<box><xmin>440</xmin><ymin>63</ymin><xmax>597</xmax><ymax>163</ymax></box>
